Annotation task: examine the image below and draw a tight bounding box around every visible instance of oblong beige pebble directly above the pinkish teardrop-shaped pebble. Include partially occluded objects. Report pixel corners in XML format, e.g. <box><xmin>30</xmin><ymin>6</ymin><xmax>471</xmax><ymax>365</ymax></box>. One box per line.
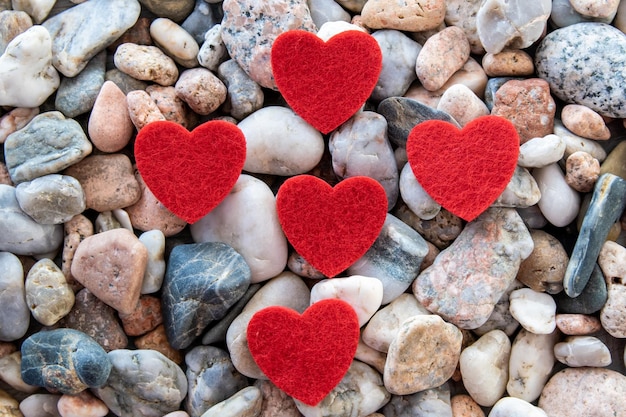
<box><xmin>113</xmin><ymin>43</ymin><xmax>178</xmax><ymax>85</ymax></box>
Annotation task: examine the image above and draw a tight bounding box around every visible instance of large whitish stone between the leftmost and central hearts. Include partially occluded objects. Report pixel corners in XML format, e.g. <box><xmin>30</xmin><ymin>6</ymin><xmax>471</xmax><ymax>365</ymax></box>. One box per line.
<box><xmin>189</xmin><ymin>174</ymin><xmax>288</xmax><ymax>283</ymax></box>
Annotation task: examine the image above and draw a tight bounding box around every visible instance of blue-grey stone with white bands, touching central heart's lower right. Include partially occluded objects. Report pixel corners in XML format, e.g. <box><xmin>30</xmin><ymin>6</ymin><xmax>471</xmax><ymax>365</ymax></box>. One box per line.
<box><xmin>348</xmin><ymin>214</ymin><xmax>428</xmax><ymax>304</ymax></box>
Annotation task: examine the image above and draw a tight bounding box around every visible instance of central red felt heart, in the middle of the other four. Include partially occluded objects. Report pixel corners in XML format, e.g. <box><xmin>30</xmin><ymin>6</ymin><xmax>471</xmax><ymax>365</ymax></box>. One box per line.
<box><xmin>276</xmin><ymin>175</ymin><xmax>387</xmax><ymax>277</ymax></box>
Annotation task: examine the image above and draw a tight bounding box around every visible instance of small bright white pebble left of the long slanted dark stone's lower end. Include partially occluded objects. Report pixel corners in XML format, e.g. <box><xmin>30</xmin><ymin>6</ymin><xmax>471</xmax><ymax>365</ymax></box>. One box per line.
<box><xmin>509</xmin><ymin>288</ymin><xmax>556</xmax><ymax>334</ymax></box>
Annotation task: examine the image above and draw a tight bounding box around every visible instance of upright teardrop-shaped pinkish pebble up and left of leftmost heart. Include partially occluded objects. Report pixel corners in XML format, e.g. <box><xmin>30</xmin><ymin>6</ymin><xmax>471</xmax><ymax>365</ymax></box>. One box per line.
<box><xmin>87</xmin><ymin>81</ymin><xmax>135</xmax><ymax>152</ymax></box>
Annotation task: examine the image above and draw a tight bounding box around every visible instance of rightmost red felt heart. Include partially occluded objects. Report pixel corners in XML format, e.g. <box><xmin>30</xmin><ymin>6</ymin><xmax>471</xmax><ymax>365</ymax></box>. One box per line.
<box><xmin>406</xmin><ymin>116</ymin><xmax>520</xmax><ymax>221</ymax></box>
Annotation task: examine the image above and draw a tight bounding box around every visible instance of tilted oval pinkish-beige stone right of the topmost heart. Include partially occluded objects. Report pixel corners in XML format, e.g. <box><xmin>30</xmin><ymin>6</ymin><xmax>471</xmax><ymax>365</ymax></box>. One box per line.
<box><xmin>415</xmin><ymin>26</ymin><xmax>470</xmax><ymax>91</ymax></box>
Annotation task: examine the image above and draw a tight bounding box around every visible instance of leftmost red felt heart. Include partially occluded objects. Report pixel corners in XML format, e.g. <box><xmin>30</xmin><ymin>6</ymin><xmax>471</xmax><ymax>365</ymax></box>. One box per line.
<box><xmin>135</xmin><ymin>120</ymin><xmax>246</xmax><ymax>223</ymax></box>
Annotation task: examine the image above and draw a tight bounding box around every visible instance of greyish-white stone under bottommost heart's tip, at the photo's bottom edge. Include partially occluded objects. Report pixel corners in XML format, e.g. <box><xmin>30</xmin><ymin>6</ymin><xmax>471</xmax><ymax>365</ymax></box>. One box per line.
<box><xmin>295</xmin><ymin>360</ymin><xmax>391</xmax><ymax>417</ymax></box>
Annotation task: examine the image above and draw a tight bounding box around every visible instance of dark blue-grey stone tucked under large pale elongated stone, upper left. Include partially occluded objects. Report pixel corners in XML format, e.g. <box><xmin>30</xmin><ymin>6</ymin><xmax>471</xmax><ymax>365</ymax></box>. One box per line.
<box><xmin>54</xmin><ymin>51</ymin><xmax>106</xmax><ymax>117</ymax></box>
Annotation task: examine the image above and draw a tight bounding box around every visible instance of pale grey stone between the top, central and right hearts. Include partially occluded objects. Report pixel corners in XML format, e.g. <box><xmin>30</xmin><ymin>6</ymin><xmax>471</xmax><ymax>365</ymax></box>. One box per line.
<box><xmin>328</xmin><ymin>111</ymin><xmax>399</xmax><ymax>210</ymax></box>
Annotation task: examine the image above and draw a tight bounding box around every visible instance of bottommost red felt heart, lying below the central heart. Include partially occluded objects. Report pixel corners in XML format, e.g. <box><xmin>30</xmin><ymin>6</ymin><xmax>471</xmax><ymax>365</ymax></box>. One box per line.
<box><xmin>247</xmin><ymin>299</ymin><xmax>359</xmax><ymax>406</ymax></box>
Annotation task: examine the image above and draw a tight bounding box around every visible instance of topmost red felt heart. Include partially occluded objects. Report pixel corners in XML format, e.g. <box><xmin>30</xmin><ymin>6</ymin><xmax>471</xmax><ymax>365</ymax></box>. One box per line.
<box><xmin>271</xmin><ymin>30</ymin><xmax>382</xmax><ymax>133</ymax></box>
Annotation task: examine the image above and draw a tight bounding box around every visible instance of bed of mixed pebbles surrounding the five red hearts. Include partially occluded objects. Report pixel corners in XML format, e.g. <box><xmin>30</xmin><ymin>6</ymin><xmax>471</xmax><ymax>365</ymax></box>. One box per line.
<box><xmin>0</xmin><ymin>0</ymin><xmax>626</xmax><ymax>417</ymax></box>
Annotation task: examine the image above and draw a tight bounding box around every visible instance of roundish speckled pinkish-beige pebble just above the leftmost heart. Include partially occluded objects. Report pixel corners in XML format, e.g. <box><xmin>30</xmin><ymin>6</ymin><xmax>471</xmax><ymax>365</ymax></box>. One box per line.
<box><xmin>176</xmin><ymin>68</ymin><xmax>227</xmax><ymax>115</ymax></box>
